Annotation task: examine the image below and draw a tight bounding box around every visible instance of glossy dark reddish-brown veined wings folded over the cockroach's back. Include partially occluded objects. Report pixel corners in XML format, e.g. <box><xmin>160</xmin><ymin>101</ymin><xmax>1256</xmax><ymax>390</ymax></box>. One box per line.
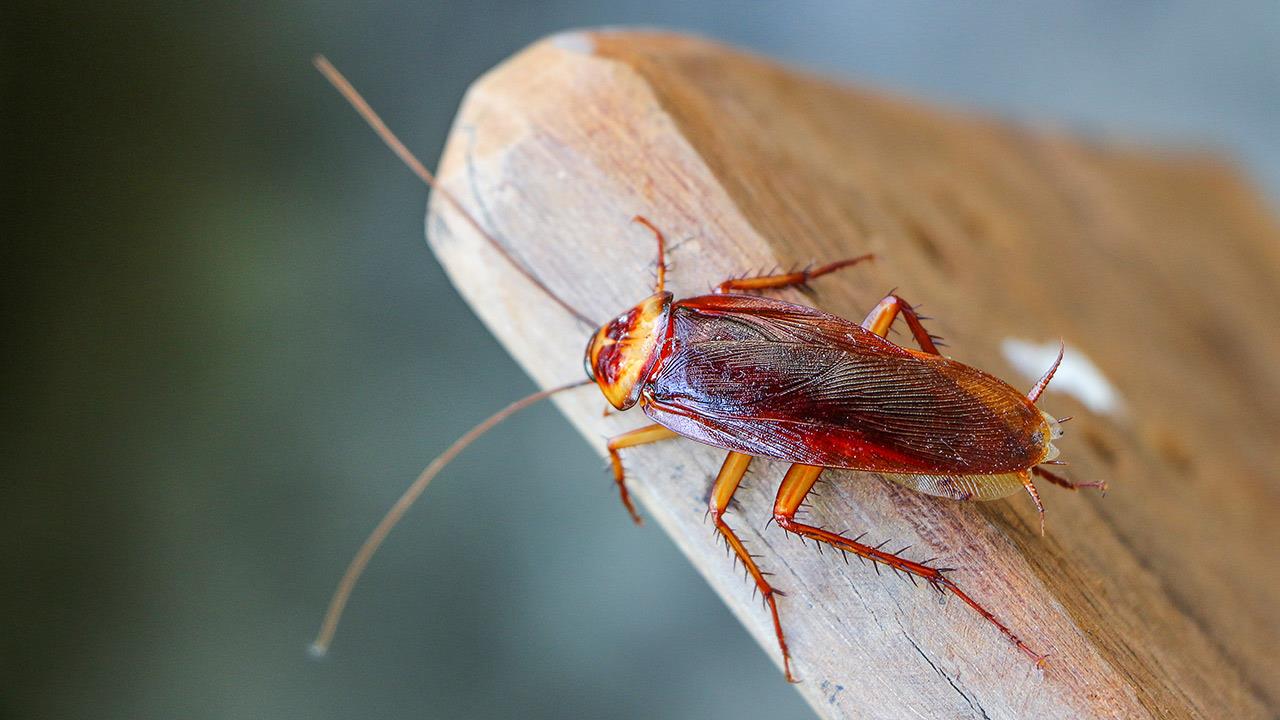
<box><xmin>643</xmin><ymin>296</ymin><xmax>1047</xmax><ymax>475</ymax></box>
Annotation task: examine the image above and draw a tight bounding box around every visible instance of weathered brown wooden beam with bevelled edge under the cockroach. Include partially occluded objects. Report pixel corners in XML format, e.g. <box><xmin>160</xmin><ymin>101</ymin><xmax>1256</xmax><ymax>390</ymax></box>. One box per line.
<box><xmin>429</xmin><ymin>32</ymin><xmax>1280</xmax><ymax>717</ymax></box>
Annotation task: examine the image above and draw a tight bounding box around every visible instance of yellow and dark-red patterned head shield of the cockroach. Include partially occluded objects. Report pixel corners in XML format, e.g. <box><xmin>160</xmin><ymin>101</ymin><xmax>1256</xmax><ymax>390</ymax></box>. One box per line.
<box><xmin>584</xmin><ymin>292</ymin><xmax>672</xmax><ymax>410</ymax></box>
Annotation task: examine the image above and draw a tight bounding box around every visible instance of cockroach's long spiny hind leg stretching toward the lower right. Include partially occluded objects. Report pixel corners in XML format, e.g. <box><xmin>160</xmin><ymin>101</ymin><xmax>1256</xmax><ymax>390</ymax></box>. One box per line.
<box><xmin>773</xmin><ymin>464</ymin><xmax>1044</xmax><ymax>666</ymax></box>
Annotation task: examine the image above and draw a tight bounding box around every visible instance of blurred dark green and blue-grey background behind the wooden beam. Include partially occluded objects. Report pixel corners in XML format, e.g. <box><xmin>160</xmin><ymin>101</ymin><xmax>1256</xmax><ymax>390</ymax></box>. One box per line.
<box><xmin>0</xmin><ymin>0</ymin><xmax>1280</xmax><ymax>719</ymax></box>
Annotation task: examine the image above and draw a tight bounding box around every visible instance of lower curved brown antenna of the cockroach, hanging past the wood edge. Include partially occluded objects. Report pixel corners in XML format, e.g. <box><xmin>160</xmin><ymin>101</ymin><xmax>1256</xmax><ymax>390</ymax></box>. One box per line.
<box><xmin>311</xmin><ymin>380</ymin><xmax>591</xmax><ymax>657</ymax></box>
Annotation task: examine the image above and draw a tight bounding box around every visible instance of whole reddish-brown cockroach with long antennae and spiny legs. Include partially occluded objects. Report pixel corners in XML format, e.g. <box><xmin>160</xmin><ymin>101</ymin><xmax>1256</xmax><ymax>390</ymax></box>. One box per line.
<box><xmin>312</xmin><ymin>58</ymin><xmax>1105</xmax><ymax>682</ymax></box>
